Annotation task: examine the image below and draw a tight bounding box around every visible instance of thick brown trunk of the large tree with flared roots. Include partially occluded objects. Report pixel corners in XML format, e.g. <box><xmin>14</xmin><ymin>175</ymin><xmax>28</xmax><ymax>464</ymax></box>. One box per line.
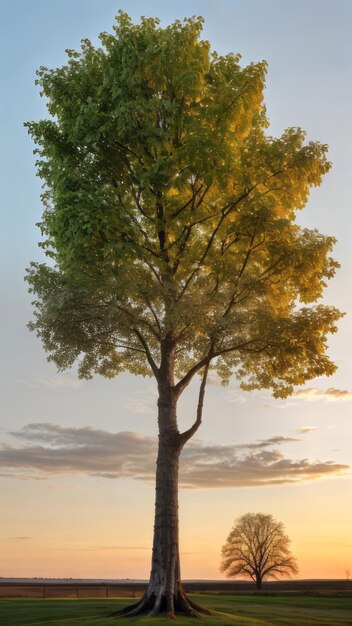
<box><xmin>114</xmin><ymin>382</ymin><xmax>211</xmax><ymax>619</ymax></box>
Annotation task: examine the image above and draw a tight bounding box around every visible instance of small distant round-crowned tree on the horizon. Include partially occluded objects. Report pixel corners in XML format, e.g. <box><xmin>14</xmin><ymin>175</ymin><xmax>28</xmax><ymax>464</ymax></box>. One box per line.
<box><xmin>220</xmin><ymin>513</ymin><xmax>298</xmax><ymax>591</ymax></box>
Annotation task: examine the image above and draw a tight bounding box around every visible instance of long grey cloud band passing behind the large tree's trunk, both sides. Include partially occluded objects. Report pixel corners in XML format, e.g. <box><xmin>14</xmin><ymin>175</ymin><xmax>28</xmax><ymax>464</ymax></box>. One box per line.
<box><xmin>0</xmin><ymin>423</ymin><xmax>350</xmax><ymax>488</ymax></box>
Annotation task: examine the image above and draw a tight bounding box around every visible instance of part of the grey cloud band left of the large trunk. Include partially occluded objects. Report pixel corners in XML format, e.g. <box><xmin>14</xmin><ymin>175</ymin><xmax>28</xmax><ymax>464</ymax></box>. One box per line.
<box><xmin>0</xmin><ymin>423</ymin><xmax>156</xmax><ymax>479</ymax></box>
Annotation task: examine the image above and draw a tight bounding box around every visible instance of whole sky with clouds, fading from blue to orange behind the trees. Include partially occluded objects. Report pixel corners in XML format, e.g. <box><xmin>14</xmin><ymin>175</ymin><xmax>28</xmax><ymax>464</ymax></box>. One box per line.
<box><xmin>0</xmin><ymin>0</ymin><xmax>352</xmax><ymax>579</ymax></box>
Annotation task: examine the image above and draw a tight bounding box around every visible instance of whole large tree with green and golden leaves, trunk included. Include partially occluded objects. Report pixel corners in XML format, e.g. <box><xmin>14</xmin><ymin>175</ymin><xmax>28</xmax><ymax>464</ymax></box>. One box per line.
<box><xmin>27</xmin><ymin>13</ymin><xmax>340</xmax><ymax>615</ymax></box>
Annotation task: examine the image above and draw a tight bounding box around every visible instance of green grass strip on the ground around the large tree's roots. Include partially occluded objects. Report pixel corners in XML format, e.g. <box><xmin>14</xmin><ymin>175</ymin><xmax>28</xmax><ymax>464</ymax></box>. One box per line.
<box><xmin>0</xmin><ymin>595</ymin><xmax>352</xmax><ymax>626</ymax></box>
